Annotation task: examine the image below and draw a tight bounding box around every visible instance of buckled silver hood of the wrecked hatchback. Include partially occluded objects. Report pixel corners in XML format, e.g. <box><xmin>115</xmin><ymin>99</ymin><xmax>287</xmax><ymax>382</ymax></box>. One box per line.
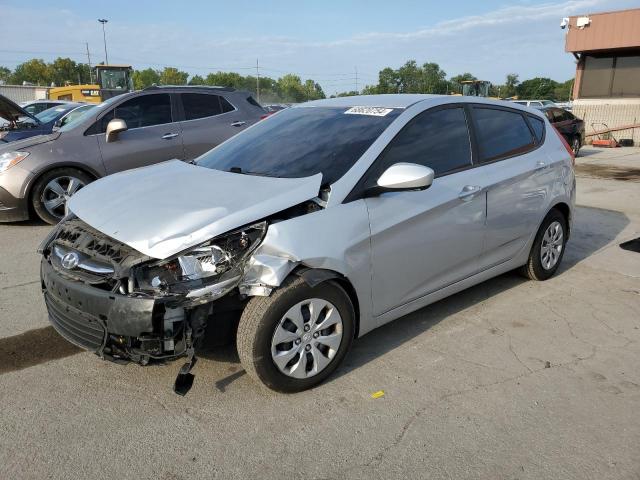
<box><xmin>68</xmin><ymin>160</ymin><xmax>322</xmax><ymax>259</ymax></box>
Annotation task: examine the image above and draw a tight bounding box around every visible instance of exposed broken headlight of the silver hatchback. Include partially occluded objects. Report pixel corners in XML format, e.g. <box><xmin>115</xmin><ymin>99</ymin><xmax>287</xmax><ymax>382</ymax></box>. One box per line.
<box><xmin>138</xmin><ymin>222</ymin><xmax>267</xmax><ymax>296</ymax></box>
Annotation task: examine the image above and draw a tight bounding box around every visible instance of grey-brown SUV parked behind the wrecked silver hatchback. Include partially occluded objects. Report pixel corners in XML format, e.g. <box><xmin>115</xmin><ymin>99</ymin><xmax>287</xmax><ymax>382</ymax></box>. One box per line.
<box><xmin>0</xmin><ymin>87</ymin><xmax>266</xmax><ymax>223</ymax></box>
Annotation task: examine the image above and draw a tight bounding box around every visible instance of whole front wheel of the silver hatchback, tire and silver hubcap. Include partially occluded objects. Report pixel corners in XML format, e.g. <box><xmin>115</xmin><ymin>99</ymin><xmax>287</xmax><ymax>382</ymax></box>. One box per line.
<box><xmin>237</xmin><ymin>276</ymin><xmax>355</xmax><ymax>392</ymax></box>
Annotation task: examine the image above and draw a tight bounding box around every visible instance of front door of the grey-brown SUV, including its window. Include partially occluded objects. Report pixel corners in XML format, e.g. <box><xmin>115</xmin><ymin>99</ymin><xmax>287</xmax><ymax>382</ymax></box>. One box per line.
<box><xmin>92</xmin><ymin>93</ymin><xmax>184</xmax><ymax>174</ymax></box>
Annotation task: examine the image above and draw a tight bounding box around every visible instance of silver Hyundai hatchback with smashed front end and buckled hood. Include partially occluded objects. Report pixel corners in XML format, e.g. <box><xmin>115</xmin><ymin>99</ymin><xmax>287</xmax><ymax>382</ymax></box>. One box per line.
<box><xmin>40</xmin><ymin>95</ymin><xmax>575</xmax><ymax>394</ymax></box>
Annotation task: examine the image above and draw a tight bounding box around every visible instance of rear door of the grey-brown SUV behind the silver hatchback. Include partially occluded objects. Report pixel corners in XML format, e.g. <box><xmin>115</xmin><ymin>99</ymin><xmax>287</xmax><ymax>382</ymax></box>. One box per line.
<box><xmin>180</xmin><ymin>93</ymin><xmax>248</xmax><ymax>160</ymax></box>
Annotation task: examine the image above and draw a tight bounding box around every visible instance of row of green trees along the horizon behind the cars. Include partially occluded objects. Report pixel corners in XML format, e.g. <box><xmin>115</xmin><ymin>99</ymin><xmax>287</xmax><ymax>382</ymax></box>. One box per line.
<box><xmin>0</xmin><ymin>58</ymin><xmax>573</xmax><ymax>103</ymax></box>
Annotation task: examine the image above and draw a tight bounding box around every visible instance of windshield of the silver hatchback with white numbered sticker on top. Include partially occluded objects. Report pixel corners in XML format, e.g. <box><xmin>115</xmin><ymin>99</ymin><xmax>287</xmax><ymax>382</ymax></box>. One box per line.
<box><xmin>196</xmin><ymin>107</ymin><xmax>401</xmax><ymax>185</ymax></box>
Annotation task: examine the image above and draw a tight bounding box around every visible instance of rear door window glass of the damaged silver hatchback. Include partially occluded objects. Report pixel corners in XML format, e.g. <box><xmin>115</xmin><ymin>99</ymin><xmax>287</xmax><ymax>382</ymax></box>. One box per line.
<box><xmin>473</xmin><ymin>107</ymin><xmax>535</xmax><ymax>162</ymax></box>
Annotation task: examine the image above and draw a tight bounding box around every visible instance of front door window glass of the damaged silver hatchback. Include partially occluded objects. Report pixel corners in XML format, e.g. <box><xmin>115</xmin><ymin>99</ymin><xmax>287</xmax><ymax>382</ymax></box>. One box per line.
<box><xmin>376</xmin><ymin>107</ymin><xmax>471</xmax><ymax>176</ymax></box>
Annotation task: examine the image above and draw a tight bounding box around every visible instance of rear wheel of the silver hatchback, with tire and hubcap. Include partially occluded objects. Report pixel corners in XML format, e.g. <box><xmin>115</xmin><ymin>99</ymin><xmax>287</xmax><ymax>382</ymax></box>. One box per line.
<box><xmin>522</xmin><ymin>209</ymin><xmax>567</xmax><ymax>280</ymax></box>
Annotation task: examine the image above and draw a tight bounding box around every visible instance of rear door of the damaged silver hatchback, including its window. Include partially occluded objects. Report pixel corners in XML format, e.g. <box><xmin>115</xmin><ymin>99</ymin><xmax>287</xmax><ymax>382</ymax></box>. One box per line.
<box><xmin>471</xmin><ymin>105</ymin><xmax>550</xmax><ymax>269</ymax></box>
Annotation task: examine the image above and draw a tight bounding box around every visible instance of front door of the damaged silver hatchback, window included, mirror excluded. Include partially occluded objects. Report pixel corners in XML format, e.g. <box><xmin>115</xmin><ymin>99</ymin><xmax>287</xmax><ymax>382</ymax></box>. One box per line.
<box><xmin>366</xmin><ymin>104</ymin><xmax>486</xmax><ymax>315</ymax></box>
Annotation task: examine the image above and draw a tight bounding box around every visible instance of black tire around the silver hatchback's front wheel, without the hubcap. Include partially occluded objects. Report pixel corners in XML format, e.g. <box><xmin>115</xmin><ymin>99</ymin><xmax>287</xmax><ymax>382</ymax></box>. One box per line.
<box><xmin>237</xmin><ymin>276</ymin><xmax>355</xmax><ymax>393</ymax></box>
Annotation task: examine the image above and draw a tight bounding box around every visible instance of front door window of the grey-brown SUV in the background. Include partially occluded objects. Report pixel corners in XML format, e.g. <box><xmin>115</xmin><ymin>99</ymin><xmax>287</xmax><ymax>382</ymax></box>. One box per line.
<box><xmin>91</xmin><ymin>93</ymin><xmax>172</xmax><ymax>133</ymax></box>
